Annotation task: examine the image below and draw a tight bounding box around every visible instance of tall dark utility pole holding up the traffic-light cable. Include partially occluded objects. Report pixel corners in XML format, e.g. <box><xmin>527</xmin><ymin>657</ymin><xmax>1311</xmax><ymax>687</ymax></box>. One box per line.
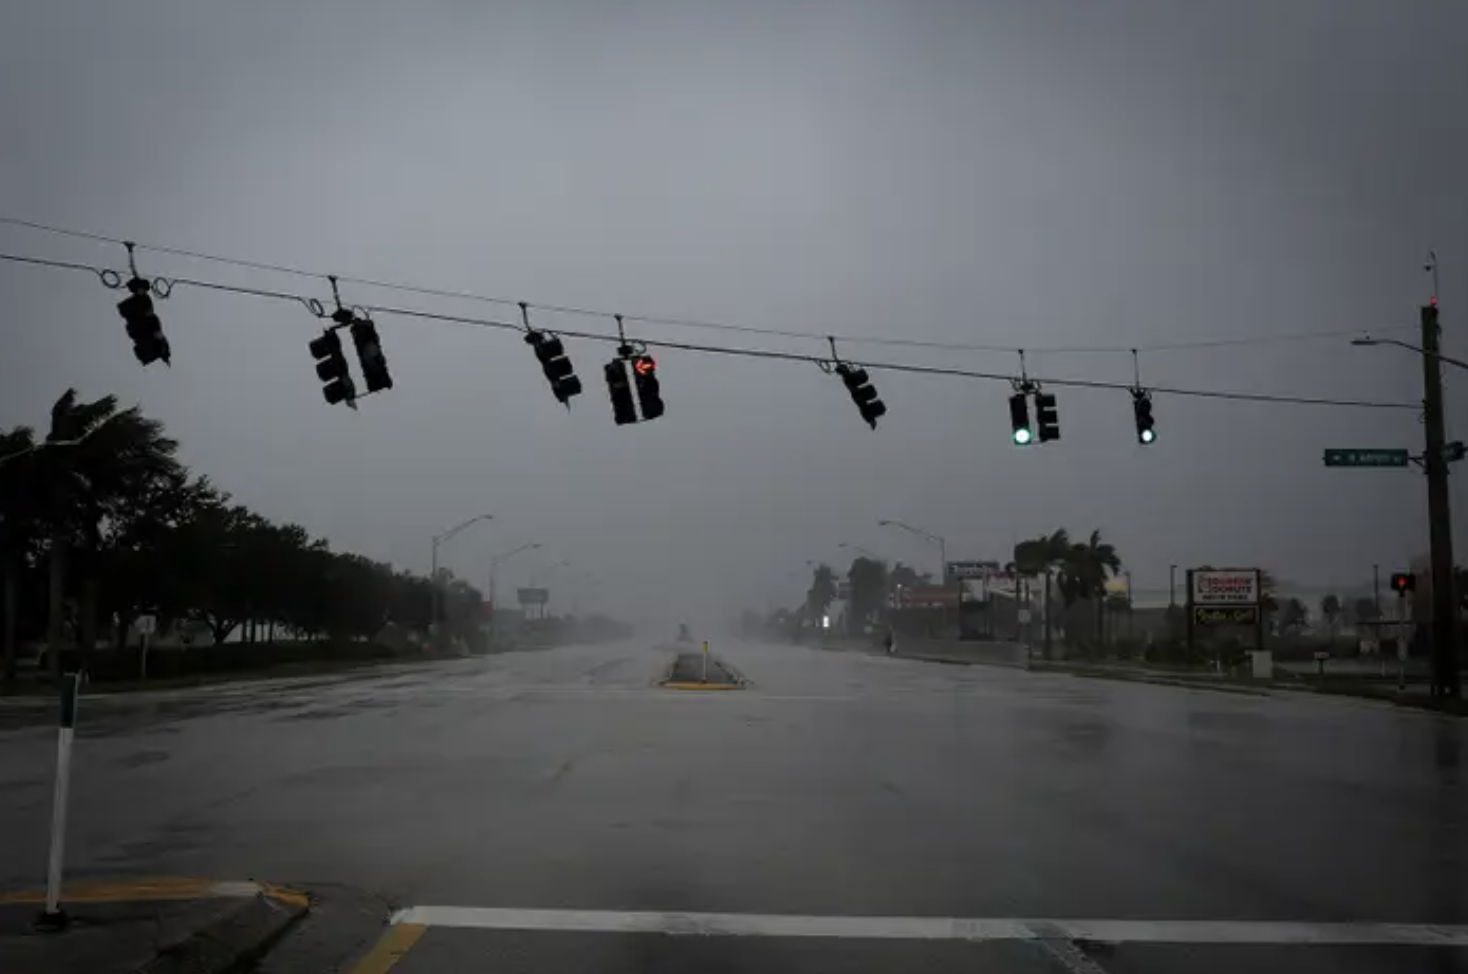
<box><xmin>1422</xmin><ymin>301</ymin><xmax>1461</xmax><ymax>696</ymax></box>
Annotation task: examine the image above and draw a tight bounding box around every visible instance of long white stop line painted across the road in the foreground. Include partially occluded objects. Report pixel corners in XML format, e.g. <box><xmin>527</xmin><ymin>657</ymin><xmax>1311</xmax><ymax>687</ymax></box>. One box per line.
<box><xmin>392</xmin><ymin>906</ymin><xmax>1468</xmax><ymax>948</ymax></box>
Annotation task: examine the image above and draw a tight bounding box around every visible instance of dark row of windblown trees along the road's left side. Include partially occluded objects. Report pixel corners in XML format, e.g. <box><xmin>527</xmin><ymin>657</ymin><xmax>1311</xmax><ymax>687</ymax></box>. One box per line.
<box><xmin>0</xmin><ymin>389</ymin><xmax>480</xmax><ymax>680</ymax></box>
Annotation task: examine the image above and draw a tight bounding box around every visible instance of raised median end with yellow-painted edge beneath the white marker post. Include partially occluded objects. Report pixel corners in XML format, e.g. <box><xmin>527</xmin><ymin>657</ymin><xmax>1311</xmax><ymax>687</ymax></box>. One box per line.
<box><xmin>0</xmin><ymin>877</ymin><xmax>313</xmax><ymax>974</ymax></box>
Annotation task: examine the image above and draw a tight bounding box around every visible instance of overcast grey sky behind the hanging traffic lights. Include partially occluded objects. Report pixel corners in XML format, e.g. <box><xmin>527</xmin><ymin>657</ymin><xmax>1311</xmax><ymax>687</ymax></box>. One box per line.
<box><xmin>0</xmin><ymin>0</ymin><xmax>1468</xmax><ymax>625</ymax></box>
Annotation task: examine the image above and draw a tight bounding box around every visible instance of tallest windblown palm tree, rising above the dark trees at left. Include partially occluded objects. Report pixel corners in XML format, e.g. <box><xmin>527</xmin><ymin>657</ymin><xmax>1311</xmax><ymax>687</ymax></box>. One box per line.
<box><xmin>32</xmin><ymin>389</ymin><xmax>182</xmax><ymax>674</ymax></box>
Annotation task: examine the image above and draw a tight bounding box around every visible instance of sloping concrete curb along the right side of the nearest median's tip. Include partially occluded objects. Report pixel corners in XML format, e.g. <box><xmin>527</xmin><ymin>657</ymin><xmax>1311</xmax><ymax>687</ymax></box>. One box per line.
<box><xmin>138</xmin><ymin>883</ymin><xmax>311</xmax><ymax>974</ymax></box>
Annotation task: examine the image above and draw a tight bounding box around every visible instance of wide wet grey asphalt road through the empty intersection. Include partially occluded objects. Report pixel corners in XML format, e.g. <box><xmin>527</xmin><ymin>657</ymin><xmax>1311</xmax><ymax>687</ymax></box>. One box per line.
<box><xmin>0</xmin><ymin>639</ymin><xmax>1468</xmax><ymax>974</ymax></box>
